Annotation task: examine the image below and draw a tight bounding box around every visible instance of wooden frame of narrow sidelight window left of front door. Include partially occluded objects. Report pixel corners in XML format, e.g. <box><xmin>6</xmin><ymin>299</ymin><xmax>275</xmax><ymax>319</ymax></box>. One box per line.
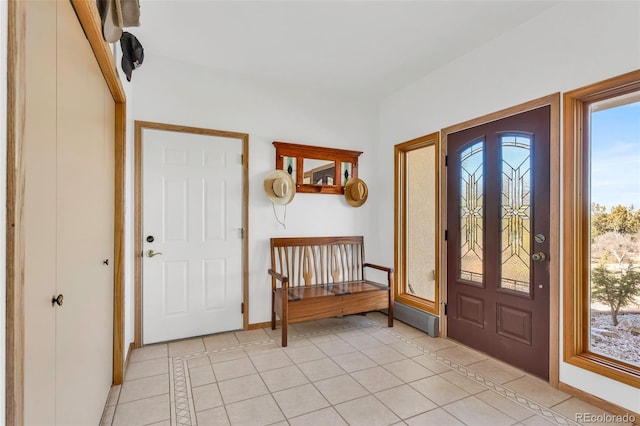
<box><xmin>394</xmin><ymin>132</ymin><xmax>441</xmax><ymax>315</ymax></box>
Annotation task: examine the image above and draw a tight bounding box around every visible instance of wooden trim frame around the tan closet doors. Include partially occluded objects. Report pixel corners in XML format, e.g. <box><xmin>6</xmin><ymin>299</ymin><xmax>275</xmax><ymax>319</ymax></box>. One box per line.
<box><xmin>5</xmin><ymin>0</ymin><xmax>126</xmax><ymax>425</ymax></box>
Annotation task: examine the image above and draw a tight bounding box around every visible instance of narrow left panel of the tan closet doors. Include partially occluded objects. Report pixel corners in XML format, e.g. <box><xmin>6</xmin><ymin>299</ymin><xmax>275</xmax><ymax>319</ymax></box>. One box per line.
<box><xmin>24</xmin><ymin>1</ymin><xmax>57</xmax><ymax>425</ymax></box>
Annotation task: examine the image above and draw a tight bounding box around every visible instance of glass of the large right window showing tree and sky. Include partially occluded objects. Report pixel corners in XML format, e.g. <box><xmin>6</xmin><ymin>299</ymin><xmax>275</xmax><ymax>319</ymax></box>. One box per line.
<box><xmin>588</xmin><ymin>96</ymin><xmax>640</xmax><ymax>366</ymax></box>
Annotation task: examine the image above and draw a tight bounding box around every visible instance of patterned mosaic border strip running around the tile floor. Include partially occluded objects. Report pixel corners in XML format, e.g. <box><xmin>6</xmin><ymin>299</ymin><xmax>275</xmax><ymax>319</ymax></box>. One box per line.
<box><xmin>169</xmin><ymin>319</ymin><xmax>579</xmax><ymax>426</ymax></box>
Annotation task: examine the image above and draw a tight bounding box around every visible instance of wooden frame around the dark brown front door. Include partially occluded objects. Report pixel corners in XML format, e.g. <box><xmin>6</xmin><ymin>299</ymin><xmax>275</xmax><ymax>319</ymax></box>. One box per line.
<box><xmin>439</xmin><ymin>93</ymin><xmax>561</xmax><ymax>388</ymax></box>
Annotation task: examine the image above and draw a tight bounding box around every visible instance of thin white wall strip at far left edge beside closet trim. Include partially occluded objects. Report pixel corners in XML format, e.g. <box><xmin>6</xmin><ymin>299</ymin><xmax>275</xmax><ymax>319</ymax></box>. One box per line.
<box><xmin>0</xmin><ymin>0</ymin><xmax>8</xmax><ymax>423</ymax></box>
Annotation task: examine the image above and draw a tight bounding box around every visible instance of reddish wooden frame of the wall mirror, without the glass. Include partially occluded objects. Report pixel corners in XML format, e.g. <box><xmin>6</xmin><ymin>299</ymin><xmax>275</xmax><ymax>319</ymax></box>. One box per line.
<box><xmin>273</xmin><ymin>141</ymin><xmax>362</xmax><ymax>194</ymax></box>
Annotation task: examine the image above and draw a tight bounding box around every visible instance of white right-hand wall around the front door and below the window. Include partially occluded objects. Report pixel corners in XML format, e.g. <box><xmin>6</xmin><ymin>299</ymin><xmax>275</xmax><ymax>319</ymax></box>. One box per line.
<box><xmin>372</xmin><ymin>1</ymin><xmax>640</xmax><ymax>412</ymax></box>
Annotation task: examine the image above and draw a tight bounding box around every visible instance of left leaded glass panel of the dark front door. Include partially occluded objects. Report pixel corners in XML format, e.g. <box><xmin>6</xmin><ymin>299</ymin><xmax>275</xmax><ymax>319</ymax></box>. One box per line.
<box><xmin>458</xmin><ymin>141</ymin><xmax>484</xmax><ymax>283</ymax></box>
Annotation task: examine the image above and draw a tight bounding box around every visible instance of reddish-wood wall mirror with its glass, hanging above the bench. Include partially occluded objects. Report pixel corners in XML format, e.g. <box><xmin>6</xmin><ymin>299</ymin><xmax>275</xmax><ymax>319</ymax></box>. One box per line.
<box><xmin>273</xmin><ymin>142</ymin><xmax>362</xmax><ymax>194</ymax></box>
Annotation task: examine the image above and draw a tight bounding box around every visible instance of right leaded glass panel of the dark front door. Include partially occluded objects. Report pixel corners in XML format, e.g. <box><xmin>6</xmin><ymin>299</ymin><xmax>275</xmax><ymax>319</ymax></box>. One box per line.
<box><xmin>500</xmin><ymin>135</ymin><xmax>531</xmax><ymax>293</ymax></box>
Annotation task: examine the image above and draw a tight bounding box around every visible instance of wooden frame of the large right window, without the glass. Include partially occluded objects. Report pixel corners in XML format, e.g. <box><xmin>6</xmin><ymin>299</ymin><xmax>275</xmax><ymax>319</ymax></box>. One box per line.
<box><xmin>562</xmin><ymin>70</ymin><xmax>640</xmax><ymax>388</ymax></box>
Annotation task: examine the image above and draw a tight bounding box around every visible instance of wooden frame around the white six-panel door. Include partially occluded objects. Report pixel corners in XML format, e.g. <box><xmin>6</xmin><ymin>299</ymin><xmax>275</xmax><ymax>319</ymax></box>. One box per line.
<box><xmin>133</xmin><ymin>120</ymin><xmax>249</xmax><ymax>348</ymax></box>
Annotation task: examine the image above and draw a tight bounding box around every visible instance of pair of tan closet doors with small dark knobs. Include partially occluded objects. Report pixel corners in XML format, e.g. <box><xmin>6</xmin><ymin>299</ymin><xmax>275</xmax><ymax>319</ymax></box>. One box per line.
<box><xmin>25</xmin><ymin>0</ymin><xmax>115</xmax><ymax>425</ymax></box>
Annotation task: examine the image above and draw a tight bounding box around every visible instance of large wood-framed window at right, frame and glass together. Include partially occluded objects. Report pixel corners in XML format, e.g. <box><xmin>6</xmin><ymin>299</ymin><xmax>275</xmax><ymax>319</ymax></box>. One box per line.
<box><xmin>563</xmin><ymin>71</ymin><xmax>640</xmax><ymax>387</ymax></box>
